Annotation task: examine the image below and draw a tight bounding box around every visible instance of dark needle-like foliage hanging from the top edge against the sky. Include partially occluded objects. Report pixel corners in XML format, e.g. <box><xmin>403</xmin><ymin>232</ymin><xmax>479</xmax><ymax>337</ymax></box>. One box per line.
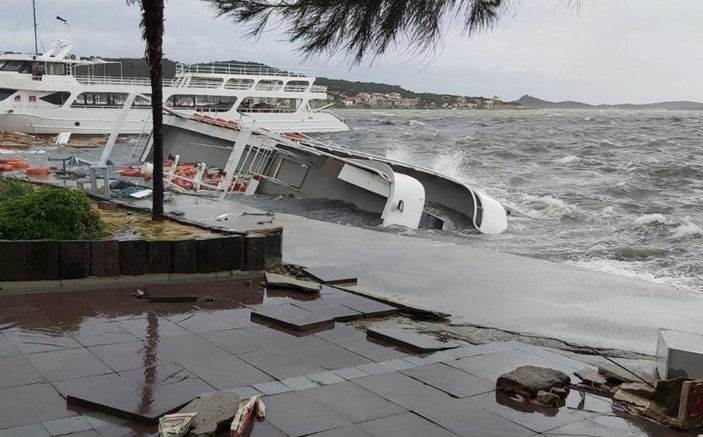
<box><xmin>203</xmin><ymin>0</ymin><xmax>508</xmax><ymax>63</ymax></box>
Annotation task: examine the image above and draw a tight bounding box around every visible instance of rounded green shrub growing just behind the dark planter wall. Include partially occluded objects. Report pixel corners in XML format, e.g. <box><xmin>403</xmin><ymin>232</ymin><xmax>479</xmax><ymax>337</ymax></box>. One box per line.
<box><xmin>0</xmin><ymin>188</ymin><xmax>105</xmax><ymax>240</ymax></box>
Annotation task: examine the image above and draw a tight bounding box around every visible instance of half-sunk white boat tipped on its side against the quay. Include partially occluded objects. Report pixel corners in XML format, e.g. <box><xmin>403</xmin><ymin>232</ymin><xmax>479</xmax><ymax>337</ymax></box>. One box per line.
<box><xmin>142</xmin><ymin>112</ymin><xmax>507</xmax><ymax>234</ymax></box>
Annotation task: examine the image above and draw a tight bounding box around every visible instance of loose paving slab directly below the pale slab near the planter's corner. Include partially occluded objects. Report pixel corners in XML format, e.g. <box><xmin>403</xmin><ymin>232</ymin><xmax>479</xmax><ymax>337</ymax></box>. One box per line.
<box><xmin>251</xmin><ymin>304</ymin><xmax>335</xmax><ymax>331</ymax></box>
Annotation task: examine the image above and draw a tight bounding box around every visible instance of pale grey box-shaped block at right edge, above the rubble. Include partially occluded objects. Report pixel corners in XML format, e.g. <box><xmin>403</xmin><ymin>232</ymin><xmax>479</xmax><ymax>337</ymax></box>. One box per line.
<box><xmin>657</xmin><ymin>329</ymin><xmax>703</xmax><ymax>379</ymax></box>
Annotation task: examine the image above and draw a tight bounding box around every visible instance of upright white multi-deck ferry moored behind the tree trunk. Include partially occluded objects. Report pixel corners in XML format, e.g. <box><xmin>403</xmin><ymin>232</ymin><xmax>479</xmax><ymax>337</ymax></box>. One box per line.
<box><xmin>0</xmin><ymin>40</ymin><xmax>348</xmax><ymax>135</ymax></box>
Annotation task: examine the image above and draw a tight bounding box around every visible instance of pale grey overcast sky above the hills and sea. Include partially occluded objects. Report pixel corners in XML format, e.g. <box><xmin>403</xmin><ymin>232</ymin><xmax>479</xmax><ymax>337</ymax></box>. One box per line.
<box><xmin>0</xmin><ymin>0</ymin><xmax>703</xmax><ymax>103</ymax></box>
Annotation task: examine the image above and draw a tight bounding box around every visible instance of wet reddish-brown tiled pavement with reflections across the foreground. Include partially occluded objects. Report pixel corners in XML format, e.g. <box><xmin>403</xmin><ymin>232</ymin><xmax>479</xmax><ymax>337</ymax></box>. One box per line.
<box><xmin>0</xmin><ymin>277</ymin><xmax>697</xmax><ymax>437</ymax></box>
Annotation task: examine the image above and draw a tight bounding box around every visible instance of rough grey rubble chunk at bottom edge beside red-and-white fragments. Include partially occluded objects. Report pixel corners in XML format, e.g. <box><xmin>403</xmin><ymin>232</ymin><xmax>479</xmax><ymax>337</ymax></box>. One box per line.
<box><xmin>179</xmin><ymin>392</ymin><xmax>239</xmax><ymax>437</ymax></box>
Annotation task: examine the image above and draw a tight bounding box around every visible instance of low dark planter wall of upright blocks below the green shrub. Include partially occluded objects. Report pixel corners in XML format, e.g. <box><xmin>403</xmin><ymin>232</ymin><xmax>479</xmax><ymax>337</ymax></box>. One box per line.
<box><xmin>0</xmin><ymin>232</ymin><xmax>282</xmax><ymax>282</ymax></box>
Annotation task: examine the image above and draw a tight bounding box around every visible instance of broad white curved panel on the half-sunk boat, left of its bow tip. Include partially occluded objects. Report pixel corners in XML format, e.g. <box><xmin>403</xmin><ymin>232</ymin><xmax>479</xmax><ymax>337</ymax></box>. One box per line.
<box><xmin>381</xmin><ymin>173</ymin><xmax>425</xmax><ymax>229</ymax></box>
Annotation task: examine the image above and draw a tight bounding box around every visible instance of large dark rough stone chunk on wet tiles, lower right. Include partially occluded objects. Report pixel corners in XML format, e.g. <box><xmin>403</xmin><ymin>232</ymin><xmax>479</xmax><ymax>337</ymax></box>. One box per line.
<box><xmin>496</xmin><ymin>366</ymin><xmax>571</xmax><ymax>399</ymax></box>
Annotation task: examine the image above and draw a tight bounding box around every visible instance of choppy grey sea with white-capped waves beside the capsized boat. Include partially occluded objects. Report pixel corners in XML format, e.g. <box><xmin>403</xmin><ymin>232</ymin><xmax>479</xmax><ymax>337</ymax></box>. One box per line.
<box><xmin>260</xmin><ymin>109</ymin><xmax>703</xmax><ymax>291</ymax></box>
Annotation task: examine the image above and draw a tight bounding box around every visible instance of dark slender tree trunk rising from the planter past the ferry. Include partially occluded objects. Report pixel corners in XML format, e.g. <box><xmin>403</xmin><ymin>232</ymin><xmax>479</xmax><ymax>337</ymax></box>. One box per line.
<box><xmin>142</xmin><ymin>0</ymin><xmax>164</xmax><ymax>221</ymax></box>
